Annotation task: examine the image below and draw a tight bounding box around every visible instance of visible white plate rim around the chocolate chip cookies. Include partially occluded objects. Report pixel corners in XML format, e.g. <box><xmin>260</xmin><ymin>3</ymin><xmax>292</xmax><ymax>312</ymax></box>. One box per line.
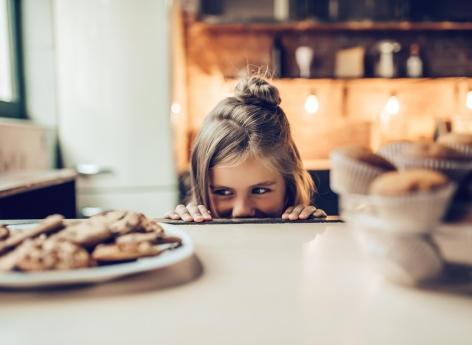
<box><xmin>0</xmin><ymin>224</ymin><xmax>194</xmax><ymax>288</ymax></box>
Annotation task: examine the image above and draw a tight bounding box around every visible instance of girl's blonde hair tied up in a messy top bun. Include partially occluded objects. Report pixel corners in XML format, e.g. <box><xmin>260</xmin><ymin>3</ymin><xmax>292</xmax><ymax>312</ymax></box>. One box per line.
<box><xmin>190</xmin><ymin>76</ymin><xmax>315</xmax><ymax>207</ymax></box>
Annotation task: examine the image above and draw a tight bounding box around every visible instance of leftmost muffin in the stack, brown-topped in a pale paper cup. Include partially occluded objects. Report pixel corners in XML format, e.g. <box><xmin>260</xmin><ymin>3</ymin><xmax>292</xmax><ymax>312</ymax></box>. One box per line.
<box><xmin>330</xmin><ymin>145</ymin><xmax>395</xmax><ymax>194</ymax></box>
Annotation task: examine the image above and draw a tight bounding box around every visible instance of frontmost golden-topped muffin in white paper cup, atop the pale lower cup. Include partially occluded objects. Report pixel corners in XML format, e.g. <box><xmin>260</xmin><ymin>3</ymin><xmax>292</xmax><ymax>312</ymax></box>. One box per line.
<box><xmin>369</xmin><ymin>169</ymin><xmax>455</xmax><ymax>234</ymax></box>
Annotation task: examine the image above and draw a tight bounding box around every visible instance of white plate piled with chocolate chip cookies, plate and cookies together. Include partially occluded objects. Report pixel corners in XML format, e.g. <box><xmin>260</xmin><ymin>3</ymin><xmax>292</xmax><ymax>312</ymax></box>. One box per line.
<box><xmin>0</xmin><ymin>211</ymin><xmax>194</xmax><ymax>288</ymax></box>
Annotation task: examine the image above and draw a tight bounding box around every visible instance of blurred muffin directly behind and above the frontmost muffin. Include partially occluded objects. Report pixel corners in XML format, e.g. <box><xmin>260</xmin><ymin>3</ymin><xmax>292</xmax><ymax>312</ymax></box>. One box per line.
<box><xmin>395</xmin><ymin>142</ymin><xmax>472</xmax><ymax>182</ymax></box>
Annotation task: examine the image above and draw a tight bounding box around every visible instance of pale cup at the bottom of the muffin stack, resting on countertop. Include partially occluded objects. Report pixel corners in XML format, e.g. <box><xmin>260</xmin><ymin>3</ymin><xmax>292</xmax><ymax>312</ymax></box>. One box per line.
<box><xmin>359</xmin><ymin>230</ymin><xmax>443</xmax><ymax>286</ymax></box>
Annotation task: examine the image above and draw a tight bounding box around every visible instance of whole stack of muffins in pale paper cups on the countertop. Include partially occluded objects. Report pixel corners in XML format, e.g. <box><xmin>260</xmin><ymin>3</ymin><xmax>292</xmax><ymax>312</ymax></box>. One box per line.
<box><xmin>331</xmin><ymin>138</ymin><xmax>472</xmax><ymax>285</ymax></box>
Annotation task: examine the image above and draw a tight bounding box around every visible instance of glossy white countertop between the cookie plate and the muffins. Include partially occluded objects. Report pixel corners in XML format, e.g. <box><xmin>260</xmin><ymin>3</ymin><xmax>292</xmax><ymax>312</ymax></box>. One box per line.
<box><xmin>0</xmin><ymin>223</ymin><xmax>472</xmax><ymax>345</ymax></box>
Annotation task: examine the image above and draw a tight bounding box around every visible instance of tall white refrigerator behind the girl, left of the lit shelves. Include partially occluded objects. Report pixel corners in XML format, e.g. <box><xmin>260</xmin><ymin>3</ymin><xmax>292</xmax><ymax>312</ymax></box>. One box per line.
<box><xmin>54</xmin><ymin>0</ymin><xmax>177</xmax><ymax>217</ymax></box>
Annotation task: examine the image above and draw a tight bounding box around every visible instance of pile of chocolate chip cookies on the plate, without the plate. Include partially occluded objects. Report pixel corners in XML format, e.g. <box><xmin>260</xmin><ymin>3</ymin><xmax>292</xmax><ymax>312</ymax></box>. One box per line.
<box><xmin>0</xmin><ymin>211</ymin><xmax>181</xmax><ymax>272</ymax></box>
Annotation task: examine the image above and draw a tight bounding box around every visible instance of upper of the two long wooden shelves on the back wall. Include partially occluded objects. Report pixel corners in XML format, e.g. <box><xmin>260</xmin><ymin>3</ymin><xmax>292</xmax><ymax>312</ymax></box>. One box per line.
<box><xmin>192</xmin><ymin>21</ymin><xmax>472</xmax><ymax>32</ymax></box>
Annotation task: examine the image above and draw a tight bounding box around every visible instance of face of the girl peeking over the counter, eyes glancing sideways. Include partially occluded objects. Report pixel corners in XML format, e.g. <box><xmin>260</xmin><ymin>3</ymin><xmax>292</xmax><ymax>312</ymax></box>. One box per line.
<box><xmin>209</xmin><ymin>157</ymin><xmax>285</xmax><ymax>218</ymax></box>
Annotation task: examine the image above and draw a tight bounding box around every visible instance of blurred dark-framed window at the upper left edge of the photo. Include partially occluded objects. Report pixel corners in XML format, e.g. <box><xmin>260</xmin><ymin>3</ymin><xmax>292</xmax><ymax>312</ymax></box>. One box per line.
<box><xmin>0</xmin><ymin>0</ymin><xmax>25</xmax><ymax>117</ymax></box>
